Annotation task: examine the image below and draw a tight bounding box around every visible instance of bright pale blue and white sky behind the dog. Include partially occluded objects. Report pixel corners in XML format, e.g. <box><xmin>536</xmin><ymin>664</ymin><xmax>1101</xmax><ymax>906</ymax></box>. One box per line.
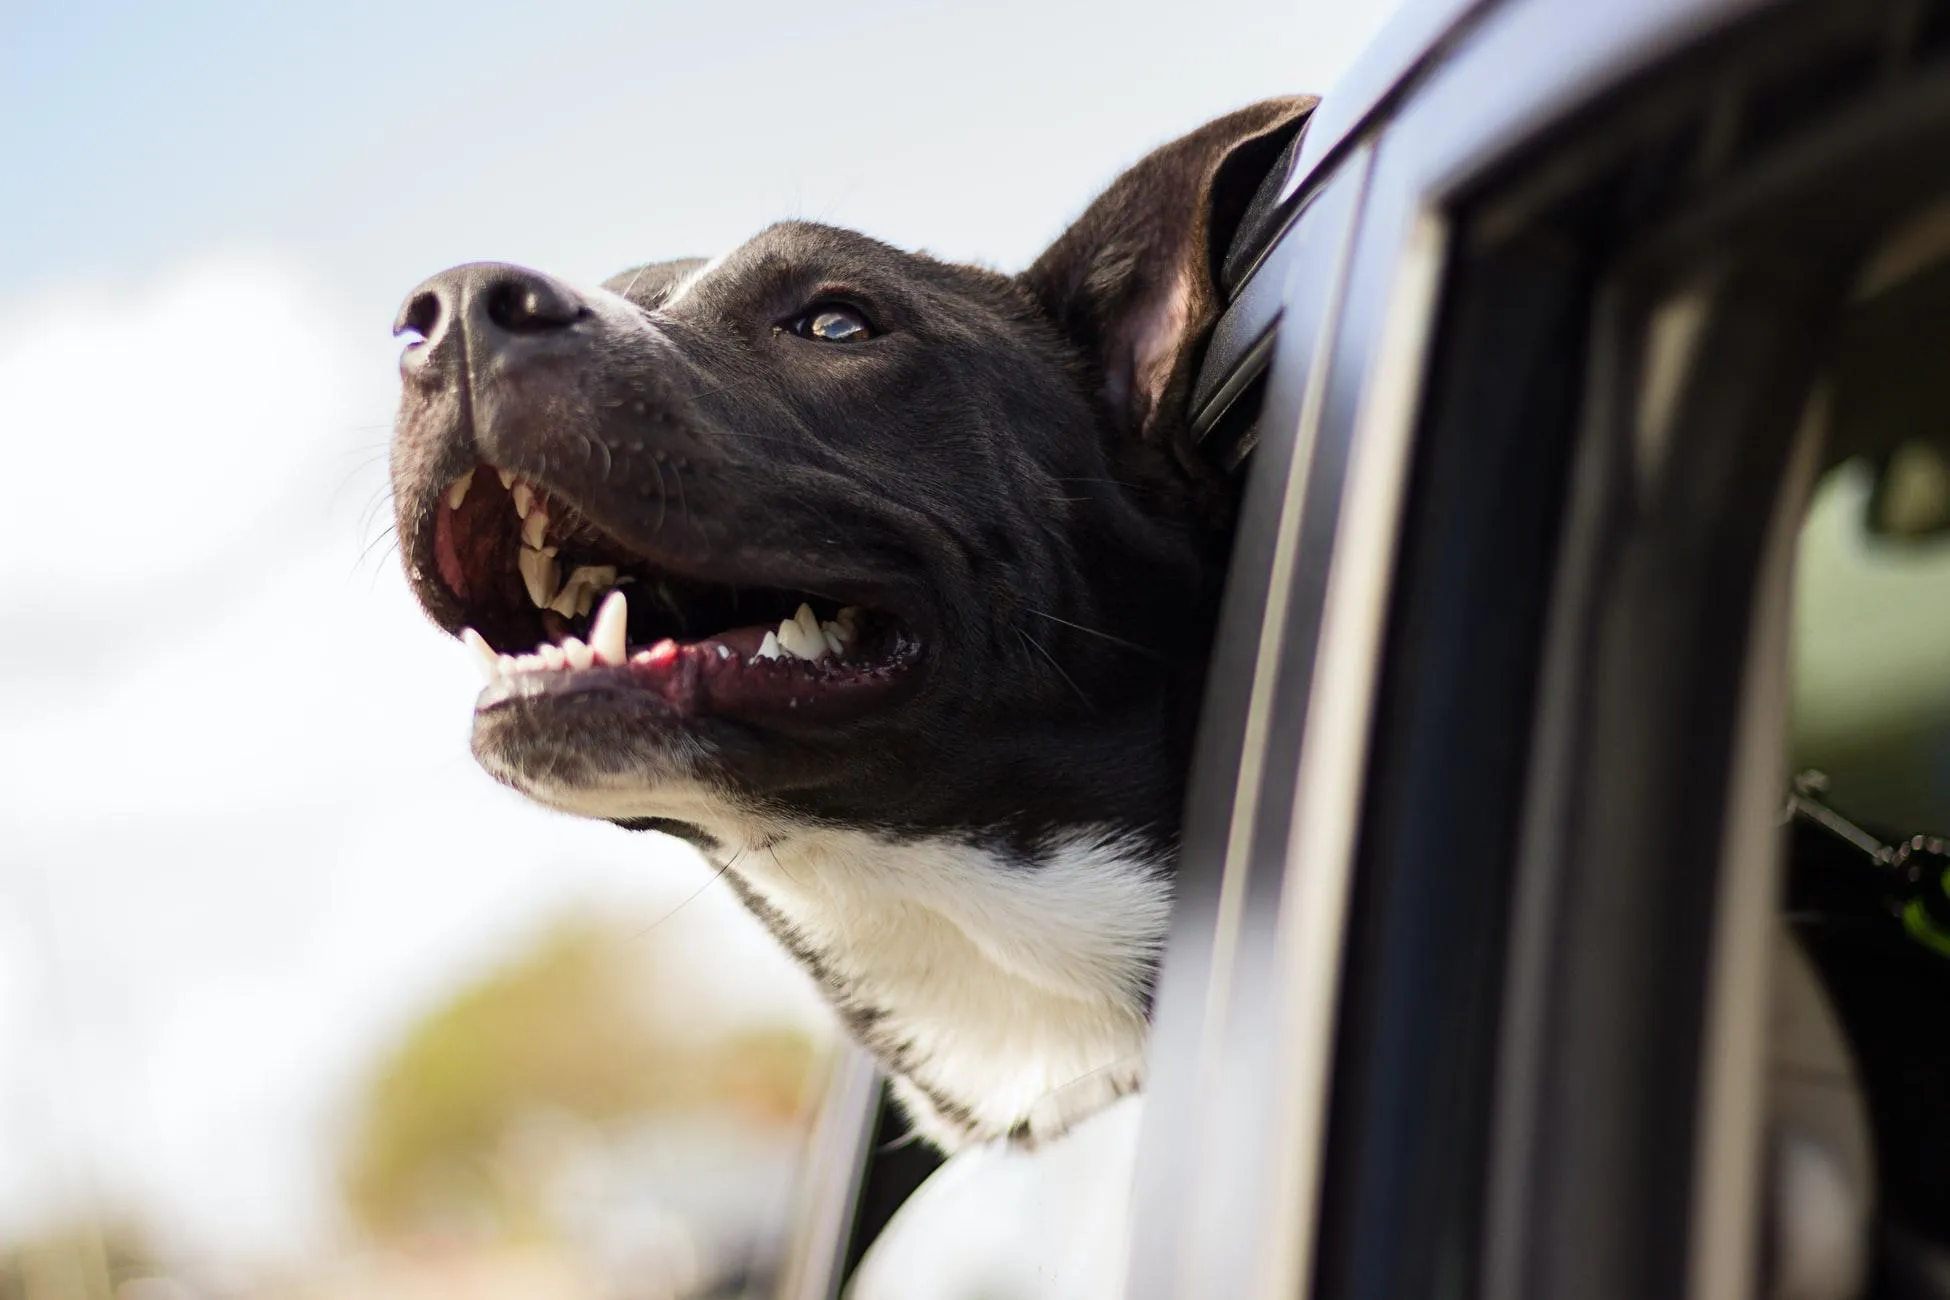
<box><xmin>0</xmin><ymin>0</ymin><xmax>1392</xmax><ymax>1251</ymax></box>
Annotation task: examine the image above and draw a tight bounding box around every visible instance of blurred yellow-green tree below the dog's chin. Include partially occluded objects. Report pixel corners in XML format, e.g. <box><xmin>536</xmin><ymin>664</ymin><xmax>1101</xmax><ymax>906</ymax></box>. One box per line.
<box><xmin>343</xmin><ymin>920</ymin><xmax>817</xmax><ymax>1240</ymax></box>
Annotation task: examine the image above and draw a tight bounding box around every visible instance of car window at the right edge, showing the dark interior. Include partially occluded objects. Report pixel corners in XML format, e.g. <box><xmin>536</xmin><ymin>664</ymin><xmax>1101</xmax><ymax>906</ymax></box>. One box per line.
<box><xmin>1775</xmin><ymin>195</ymin><xmax>1950</xmax><ymax>1296</ymax></box>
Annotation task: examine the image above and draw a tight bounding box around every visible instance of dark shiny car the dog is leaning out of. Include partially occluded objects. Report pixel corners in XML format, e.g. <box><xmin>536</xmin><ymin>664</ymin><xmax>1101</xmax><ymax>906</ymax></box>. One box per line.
<box><xmin>764</xmin><ymin>0</ymin><xmax>1950</xmax><ymax>1300</ymax></box>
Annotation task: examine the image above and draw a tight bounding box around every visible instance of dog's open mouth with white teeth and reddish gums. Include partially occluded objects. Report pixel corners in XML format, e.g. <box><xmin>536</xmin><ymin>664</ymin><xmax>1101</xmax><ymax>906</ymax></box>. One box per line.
<box><xmin>433</xmin><ymin>466</ymin><xmax>920</xmax><ymax>721</ymax></box>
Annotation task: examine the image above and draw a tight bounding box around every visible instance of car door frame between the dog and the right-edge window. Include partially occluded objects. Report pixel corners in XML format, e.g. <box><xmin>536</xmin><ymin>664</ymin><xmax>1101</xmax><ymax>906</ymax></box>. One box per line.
<box><xmin>1129</xmin><ymin>0</ymin><xmax>1950</xmax><ymax>1298</ymax></box>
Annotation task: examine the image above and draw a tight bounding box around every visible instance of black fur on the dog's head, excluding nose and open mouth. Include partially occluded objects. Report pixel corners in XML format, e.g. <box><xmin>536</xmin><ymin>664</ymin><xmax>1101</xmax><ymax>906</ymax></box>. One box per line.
<box><xmin>394</xmin><ymin>99</ymin><xmax>1310</xmax><ymax>840</ymax></box>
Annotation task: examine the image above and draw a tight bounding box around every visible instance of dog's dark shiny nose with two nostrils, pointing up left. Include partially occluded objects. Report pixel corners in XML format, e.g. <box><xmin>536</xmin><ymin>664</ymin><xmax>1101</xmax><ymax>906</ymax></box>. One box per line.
<box><xmin>392</xmin><ymin>261</ymin><xmax>587</xmax><ymax>374</ymax></box>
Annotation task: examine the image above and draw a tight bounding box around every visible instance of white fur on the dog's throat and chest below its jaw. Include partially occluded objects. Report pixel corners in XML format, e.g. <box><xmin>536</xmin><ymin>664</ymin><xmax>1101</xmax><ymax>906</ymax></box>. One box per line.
<box><xmin>525</xmin><ymin>764</ymin><xmax>1170</xmax><ymax>1150</ymax></box>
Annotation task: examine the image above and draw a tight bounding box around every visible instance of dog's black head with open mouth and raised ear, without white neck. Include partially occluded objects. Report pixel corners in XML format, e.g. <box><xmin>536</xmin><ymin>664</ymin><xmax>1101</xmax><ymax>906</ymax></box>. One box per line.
<box><xmin>394</xmin><ymin>99</ymin><xmax>1312</xmax><ymax>853</ymax></box>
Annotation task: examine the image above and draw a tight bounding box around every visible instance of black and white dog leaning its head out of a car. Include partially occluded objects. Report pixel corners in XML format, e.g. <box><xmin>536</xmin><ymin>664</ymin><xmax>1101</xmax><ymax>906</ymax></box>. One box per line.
<box><xmin>392</xmin><ymin>97</ymin><xmax>1314</xmax><ymax>1152</ymax></box>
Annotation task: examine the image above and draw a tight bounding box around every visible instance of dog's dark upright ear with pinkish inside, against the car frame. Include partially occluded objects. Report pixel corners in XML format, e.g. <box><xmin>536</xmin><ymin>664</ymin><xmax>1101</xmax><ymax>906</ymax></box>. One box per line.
<box><xmin>1022</xmin><ymin>96</ymin><xmax>1318</xmax><ymax>448</ymax></box>
